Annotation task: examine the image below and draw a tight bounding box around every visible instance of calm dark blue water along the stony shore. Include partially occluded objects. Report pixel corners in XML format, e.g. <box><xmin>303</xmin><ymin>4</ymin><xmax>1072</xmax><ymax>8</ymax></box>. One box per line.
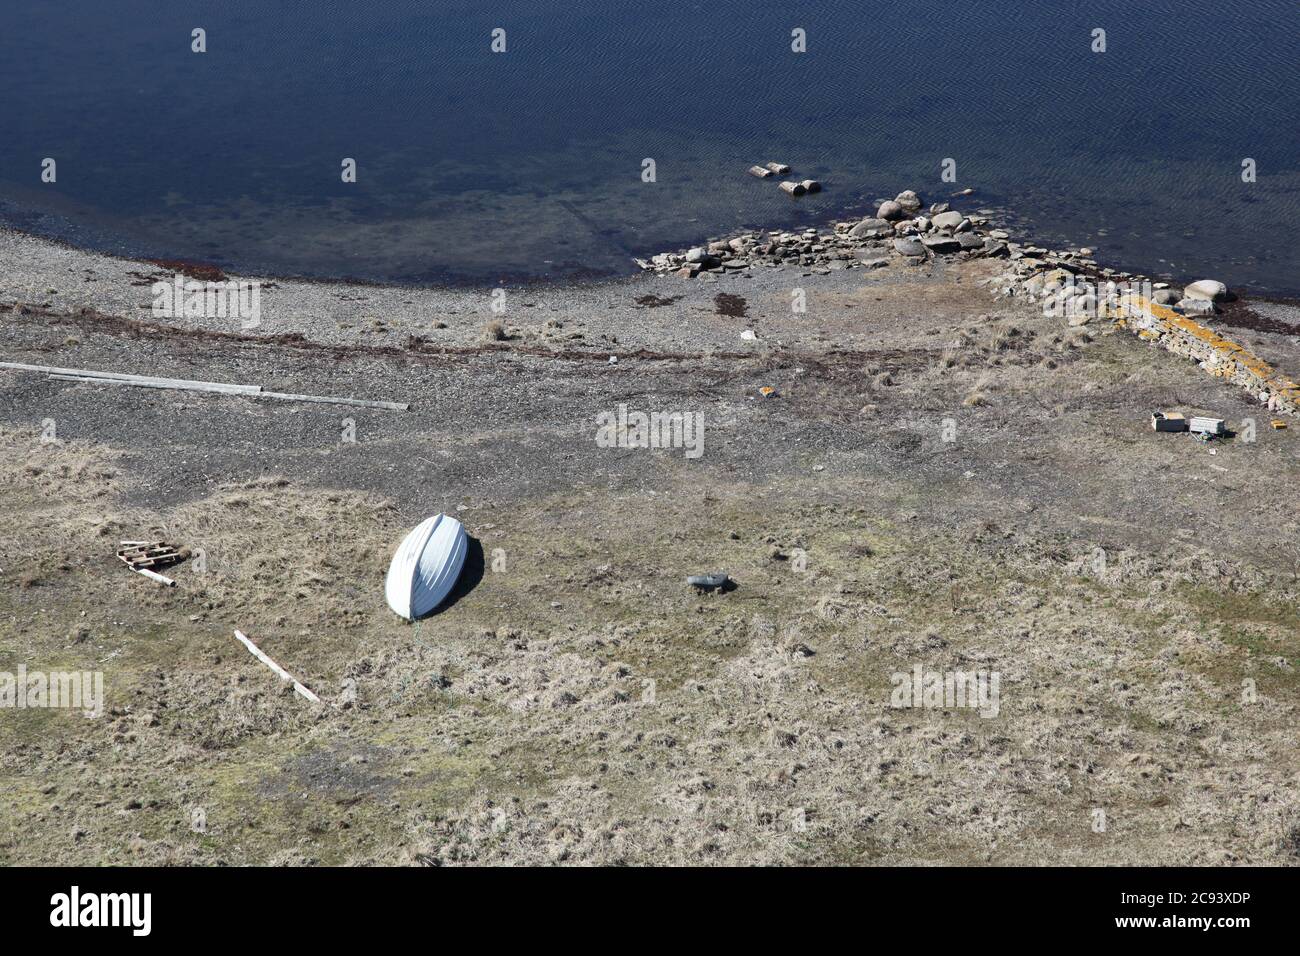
<box><xmin>0</xmin><ymin>0</ymin><xmax>1300</xmax><ymax>293</ymax></box>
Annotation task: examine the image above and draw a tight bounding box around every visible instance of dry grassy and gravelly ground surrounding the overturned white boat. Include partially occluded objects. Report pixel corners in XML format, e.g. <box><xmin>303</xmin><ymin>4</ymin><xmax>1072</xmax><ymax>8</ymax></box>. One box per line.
<box><xmin>0</xmin><ymin>238</ymin><xmax>1300</xmax><ymax>865</ymax></box>
